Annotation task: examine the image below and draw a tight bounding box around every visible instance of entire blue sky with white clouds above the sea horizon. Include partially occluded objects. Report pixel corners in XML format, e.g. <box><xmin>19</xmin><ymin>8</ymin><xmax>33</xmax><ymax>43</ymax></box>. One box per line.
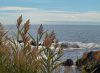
<box><xmin>0</xmin><ymin>0</ymin><xmax>100</xmax><ymax>25</ymax></box>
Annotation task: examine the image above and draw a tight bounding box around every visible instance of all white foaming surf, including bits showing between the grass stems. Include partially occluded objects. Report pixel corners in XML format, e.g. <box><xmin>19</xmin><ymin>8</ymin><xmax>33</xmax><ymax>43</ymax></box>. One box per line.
<box><xmin>13</xmin><ymin>41</ymin><xmax>100</xmax><ymax>51</ymax></box>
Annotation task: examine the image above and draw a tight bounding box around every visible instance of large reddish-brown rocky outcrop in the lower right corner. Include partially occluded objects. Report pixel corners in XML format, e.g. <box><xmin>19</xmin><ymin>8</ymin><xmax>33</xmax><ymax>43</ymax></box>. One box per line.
<box><xmin>76</xmin><ymin>51</ymin><xmax>100</xmax><ymax>73</ymax></box>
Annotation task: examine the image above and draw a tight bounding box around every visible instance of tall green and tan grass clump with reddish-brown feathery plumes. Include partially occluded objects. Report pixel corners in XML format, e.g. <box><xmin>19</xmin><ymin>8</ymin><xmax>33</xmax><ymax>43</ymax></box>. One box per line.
<box><xmin>0</xmin><ymin>15</ymin><xmax>63</xmax><ymax>73</ymax></box>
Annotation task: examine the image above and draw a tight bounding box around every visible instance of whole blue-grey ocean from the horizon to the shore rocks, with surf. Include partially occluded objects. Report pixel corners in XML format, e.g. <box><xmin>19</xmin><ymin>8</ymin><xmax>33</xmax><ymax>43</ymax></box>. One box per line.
<box><xmin>4</xmin><ymin>25</ymin><xmax>100</xmax><ymax>60</ymax></box>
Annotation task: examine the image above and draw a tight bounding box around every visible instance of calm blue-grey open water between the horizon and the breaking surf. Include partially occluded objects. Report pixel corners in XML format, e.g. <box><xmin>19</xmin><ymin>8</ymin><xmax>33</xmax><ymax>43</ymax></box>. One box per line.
<box><xmin>5</xmin><ymin>25</ymin><xmax>100</xmax><ymax>43</ymax></box>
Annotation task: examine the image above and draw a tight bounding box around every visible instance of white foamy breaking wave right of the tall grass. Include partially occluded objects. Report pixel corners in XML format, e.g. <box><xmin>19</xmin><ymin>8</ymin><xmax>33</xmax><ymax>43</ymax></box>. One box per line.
<box><xmin>59</xmin><ymin>41</ymin><xmax>100</xmax><ymax>50</ymax></box>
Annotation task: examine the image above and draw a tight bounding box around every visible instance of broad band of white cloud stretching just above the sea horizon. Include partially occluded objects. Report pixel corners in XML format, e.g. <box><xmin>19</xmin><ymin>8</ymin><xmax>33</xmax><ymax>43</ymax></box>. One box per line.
<box><xmin>0</xmin><ymin>7</ymin><xmax>100</xmax><ymax>24</ymax></box>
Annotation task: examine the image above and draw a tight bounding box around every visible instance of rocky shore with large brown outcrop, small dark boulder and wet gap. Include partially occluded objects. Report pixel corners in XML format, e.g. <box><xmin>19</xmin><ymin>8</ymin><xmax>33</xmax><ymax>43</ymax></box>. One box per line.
<box><xmin>62</xmin><ymin>50</ymin><xmax>100</xmax><ymax>73</ymax></box>
